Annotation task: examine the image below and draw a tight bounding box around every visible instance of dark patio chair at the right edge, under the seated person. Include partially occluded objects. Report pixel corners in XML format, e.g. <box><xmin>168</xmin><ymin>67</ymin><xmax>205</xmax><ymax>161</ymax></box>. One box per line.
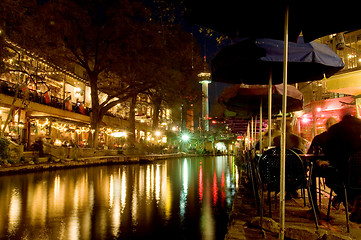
<box><xmin>327</xmin><ymin>149</ymin><xmax>361</xmax><ymax>232</ymax></box>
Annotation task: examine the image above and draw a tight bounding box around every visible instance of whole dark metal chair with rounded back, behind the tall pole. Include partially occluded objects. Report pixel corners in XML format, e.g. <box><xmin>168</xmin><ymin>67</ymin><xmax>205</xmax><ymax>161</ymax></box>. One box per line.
<box><xmin>258</xmin><ymin>148</ymin><xmax>318</xmax><ymax>229</ymax></box>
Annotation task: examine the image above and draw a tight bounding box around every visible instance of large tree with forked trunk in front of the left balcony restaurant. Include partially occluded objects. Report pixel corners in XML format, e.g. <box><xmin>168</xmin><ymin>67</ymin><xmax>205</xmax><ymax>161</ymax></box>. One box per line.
<box><xmin>2</xmin><ymin>0</ymin><xmax>159</xmax><ymax>147</ymax></box>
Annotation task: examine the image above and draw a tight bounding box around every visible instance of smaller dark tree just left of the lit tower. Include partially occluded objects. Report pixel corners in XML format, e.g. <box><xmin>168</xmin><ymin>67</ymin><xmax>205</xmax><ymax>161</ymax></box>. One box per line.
<box><xmin>145</xmin><ymin>26</ymin><xmax>202</xmax><ymax>129</ymax></box>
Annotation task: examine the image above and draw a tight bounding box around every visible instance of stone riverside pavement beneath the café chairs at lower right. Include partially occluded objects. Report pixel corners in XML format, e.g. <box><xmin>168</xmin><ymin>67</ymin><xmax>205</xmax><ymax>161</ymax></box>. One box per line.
<box><xmin>225</xmin><ymin>170</ymin><xmax>361</xmax><ymax>240</ymax></box>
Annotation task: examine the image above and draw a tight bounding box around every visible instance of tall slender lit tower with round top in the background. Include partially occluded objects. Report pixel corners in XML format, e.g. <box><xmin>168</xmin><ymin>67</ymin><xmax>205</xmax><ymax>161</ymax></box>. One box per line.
<box><xmin>198</xmin><ymin>56</ymin><xmax>212</xmax><ymax>132</ymax></box>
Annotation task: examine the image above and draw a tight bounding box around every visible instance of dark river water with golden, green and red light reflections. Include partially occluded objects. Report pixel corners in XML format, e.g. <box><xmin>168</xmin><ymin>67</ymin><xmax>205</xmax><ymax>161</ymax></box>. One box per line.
<box><xmin>0</xmin><ymin>157</ymin><xmax>238</xmax><ymax>240</ymax></box>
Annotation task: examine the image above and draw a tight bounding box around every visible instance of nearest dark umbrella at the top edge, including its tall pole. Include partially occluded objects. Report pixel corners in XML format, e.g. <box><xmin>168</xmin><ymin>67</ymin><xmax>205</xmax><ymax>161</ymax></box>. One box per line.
<box><xmin>185</xmin><ymin>0</ymin><xmax>352</xmax><ymax>236</ymax></box>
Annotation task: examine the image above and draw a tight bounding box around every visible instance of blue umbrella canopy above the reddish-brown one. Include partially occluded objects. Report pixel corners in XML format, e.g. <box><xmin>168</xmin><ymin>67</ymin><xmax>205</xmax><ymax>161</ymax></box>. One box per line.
<box><xmin>212</xmin><ymin>37</ymin><xmax>344</xmax><ymax>84</ymax></box>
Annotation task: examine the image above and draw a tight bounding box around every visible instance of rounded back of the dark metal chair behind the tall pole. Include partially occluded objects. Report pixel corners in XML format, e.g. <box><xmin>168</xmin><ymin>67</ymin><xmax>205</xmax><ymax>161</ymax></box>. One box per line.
<box><xmin>258</xmin><ymin>147</ymin><xmax>306</xmax><ymax>190</ymax></box>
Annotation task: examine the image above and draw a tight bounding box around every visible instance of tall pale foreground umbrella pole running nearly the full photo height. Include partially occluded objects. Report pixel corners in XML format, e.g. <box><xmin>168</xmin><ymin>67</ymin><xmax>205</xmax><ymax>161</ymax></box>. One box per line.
<box><xmin>279</xmin><ymin>5</ymin><xmax>289</xmax><ymax>240</ymax></box>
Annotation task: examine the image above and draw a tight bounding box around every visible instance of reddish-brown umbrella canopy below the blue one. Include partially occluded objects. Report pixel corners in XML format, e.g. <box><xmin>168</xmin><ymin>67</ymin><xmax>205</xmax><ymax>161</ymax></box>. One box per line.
<box><xmin>218</xmin><ymin>84</ymin><xmax>303</xmax><ymax>119</ymax></box>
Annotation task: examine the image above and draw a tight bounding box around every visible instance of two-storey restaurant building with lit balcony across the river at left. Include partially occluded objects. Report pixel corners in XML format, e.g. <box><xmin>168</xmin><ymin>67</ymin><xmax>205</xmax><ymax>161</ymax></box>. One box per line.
<box><xmin>0</xmin><ymin>38</ymin><xmax>171</xmax><ymax>153</ymax></box>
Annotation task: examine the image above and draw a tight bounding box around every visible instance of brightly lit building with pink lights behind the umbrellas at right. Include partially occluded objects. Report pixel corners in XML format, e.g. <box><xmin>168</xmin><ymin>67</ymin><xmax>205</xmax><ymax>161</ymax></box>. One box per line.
<box><xmin>296</xmin><ymin>30</ymin><xmax>361</xmax><ymax>141</ymax></box>
